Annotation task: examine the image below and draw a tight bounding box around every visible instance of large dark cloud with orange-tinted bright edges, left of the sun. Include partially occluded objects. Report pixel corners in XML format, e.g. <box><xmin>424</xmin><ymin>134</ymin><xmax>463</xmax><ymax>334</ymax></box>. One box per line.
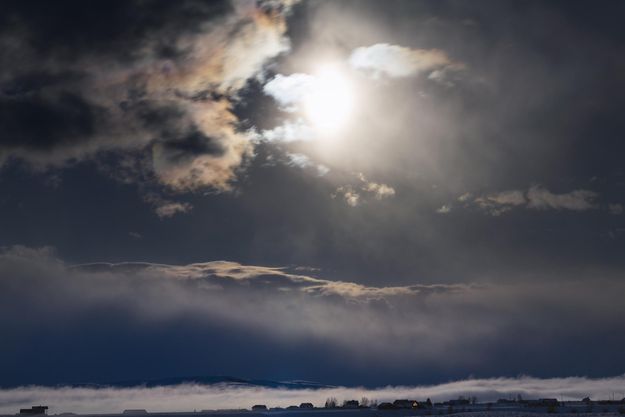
<box><xmin>0</xmin><ymin>0</ymin><xmax>290</xmax><ymax>197</ymax></box>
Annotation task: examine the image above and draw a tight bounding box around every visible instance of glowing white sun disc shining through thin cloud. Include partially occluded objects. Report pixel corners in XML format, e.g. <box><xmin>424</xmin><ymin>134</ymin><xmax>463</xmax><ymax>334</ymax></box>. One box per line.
<box><xmin>304</xmin><ymin>68</ymin><xmax>353</xmax><ymax>132</ymax></box>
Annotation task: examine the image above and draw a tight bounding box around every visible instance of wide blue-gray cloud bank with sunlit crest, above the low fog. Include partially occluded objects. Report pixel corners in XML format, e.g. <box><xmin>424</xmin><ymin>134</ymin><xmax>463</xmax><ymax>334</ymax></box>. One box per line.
<box><xmin>0</xmin><ymin>247</ymin><xmax>623</xmax><ymax>385</ymax></box>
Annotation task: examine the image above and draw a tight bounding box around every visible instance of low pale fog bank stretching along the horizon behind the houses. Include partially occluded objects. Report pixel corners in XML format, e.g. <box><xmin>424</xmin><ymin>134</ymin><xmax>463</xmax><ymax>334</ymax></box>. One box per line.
<box><xmin>0</xmin><ymin>375</ymin><xmax>625</xmax><ymax>414</ymax></box>
